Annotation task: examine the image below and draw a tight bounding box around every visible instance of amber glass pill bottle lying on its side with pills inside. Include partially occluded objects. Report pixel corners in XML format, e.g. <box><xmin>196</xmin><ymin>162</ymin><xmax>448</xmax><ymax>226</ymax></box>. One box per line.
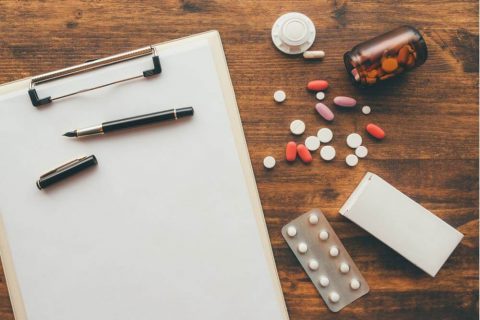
<box><xmin>343</xmin><ymin>26</ymin><xmax>428</xmax><ymax>87</ymax></box>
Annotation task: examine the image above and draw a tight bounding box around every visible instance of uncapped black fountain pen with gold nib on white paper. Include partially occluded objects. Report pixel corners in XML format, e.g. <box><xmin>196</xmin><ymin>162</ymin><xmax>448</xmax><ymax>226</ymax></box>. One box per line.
<box><xmin>63</xmin><ymin>107</ymin><xmax>193</xmax><ymax>137</ymax></box>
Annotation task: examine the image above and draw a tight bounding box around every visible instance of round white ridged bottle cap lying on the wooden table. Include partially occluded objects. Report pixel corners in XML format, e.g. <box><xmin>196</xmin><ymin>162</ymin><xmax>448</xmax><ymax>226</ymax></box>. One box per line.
<box><xmin>272</xmin><ymin>12</ymin><xmax>315</xmax><ymax>54</ymax></box>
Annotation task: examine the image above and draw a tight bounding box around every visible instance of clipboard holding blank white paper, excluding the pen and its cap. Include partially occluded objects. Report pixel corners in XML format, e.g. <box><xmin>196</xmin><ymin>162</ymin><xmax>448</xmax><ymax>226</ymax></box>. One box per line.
<box><xmin>0</xmin><ymin>31</ymin><xmax>288</xmax><ymax>320</ymax></box>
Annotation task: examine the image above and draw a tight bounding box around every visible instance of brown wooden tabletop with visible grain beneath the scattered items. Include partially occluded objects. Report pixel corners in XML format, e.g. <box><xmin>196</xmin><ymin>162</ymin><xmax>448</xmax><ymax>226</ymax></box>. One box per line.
<box><xmin>0</xmin><ymin>0</ymin><xmax>479</xmax><ymax>320</ymax></box>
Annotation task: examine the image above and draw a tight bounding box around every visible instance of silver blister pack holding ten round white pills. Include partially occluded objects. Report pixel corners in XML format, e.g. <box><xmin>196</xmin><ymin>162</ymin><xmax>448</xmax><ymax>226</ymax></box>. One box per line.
<box><xmin>282</xmin><ymin>209</ymin><xmax>370</xmax><ymax>312</ymax></box>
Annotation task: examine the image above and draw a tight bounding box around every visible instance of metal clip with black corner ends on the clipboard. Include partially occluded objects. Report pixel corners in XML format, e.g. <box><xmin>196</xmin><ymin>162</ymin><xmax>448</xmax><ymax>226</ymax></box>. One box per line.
<box><xmin>28</xmin><ymin>46</ymin><xmax>162</xmax><ymax>107</ymax></box>
